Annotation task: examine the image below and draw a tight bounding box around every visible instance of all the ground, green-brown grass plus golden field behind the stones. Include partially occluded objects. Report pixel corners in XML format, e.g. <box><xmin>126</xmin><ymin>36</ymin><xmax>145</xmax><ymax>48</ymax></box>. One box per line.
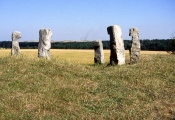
<box><xmin>0</xmin><ymin>50</ymin><xmax>175</xmax><ymax>120</ymax></box>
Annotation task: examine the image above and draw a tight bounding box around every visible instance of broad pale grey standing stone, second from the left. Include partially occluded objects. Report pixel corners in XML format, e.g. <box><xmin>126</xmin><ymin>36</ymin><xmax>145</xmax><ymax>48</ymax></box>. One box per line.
<box><xmin>38</xmin><ymin>29</ymin><xmax>52</xmax><ymax>59</ymax></box>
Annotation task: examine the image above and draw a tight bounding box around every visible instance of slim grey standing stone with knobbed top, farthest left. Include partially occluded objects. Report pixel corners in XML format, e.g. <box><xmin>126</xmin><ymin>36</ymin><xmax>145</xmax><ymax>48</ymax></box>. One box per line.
<box><xmin>11</xmin><ymin>31</ymin><xmax>21</xmax><ymax>56</ymax></box>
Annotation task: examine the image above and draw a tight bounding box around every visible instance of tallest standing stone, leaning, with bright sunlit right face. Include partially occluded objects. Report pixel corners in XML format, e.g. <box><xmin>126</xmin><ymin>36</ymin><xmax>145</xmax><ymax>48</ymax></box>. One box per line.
<box><xmin>107</xmin><ymin>25</ymin><xmax>125</xmax><ymax>65</ymax></box>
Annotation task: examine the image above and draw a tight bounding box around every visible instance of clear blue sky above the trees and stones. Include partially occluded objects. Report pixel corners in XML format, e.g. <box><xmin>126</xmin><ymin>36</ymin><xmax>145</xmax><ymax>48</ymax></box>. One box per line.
<box><xmin>0</xmin><ymin>0</ymin><xmax>175</xmax><ymax>41</ymax></box>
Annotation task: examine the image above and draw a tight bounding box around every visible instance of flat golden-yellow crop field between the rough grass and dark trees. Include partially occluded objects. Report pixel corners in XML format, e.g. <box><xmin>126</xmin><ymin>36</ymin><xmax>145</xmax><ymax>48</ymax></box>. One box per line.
<box><xmin>0</xmin><ymin>49</ymin><xmax>167</xmax><ymax>64</ymax></box>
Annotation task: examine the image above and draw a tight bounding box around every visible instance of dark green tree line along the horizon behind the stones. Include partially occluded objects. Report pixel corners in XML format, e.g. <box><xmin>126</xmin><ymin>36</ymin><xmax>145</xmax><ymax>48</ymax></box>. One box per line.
<box><xmin>0</xmin><ymin>39</ymin><xmax>175</xmax><ymax>51</ymax></box>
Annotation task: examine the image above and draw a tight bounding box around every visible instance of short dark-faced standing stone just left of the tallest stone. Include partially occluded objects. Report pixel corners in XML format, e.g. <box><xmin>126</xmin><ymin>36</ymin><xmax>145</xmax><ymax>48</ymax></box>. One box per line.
<box><xmin>94</xmin><ymin>40</ymin><xmax>104</xmax><ymax>64</ymax></box>
